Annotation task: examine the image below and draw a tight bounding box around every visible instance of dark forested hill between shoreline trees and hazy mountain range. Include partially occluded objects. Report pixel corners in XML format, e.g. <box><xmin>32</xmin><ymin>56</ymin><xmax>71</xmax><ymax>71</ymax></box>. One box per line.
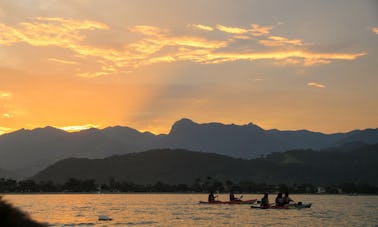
<box><xmin>33</xmin><ymin>144</ymin><xmax>378</xmax><ymax>185</ymax></box>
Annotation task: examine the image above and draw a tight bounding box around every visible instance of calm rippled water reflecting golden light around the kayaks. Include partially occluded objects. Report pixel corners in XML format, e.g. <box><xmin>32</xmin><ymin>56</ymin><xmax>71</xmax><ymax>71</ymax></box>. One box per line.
<box><xmin>4</xmin><ymin>194</ymin><xmax>378</xmax><ymax>226</ymax></box>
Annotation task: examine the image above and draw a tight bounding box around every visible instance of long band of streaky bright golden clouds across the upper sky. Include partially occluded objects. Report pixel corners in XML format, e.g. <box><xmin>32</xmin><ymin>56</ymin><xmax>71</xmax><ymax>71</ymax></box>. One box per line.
<box><xmin>0</xmin><ymin>17</ymin><xmax>365</xmax><ymax>78</ymax></box>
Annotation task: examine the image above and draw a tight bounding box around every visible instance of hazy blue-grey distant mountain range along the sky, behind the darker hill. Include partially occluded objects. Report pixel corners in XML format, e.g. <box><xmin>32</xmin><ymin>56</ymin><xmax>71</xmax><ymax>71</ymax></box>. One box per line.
<box><xmin>0</xmin><ymin>119</ymin><xmax>378</xmax><ymax>177</ymax></box>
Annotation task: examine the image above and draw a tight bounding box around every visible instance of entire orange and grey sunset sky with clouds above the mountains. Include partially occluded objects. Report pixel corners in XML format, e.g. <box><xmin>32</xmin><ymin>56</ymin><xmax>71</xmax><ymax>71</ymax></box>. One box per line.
<box><xmin>0</xmin><ymin>0</ymin><xmax>378</xmax><ymax>134</ymax></box>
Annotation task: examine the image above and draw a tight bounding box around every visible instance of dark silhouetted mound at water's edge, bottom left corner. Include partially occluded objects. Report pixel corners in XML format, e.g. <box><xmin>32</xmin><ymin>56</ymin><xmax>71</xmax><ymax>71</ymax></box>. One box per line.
<box><xmin>0</xmin><ymin>196</ymin><xmax>47</xmax><ymax>227</ymax></box>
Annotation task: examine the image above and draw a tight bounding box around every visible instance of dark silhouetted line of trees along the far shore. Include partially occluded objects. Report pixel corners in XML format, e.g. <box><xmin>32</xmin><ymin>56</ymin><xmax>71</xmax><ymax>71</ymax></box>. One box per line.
<box><xmin>0</xmin><ymin>176</ymin><xmax>378</xmax><ymax>194</ymax></box>
